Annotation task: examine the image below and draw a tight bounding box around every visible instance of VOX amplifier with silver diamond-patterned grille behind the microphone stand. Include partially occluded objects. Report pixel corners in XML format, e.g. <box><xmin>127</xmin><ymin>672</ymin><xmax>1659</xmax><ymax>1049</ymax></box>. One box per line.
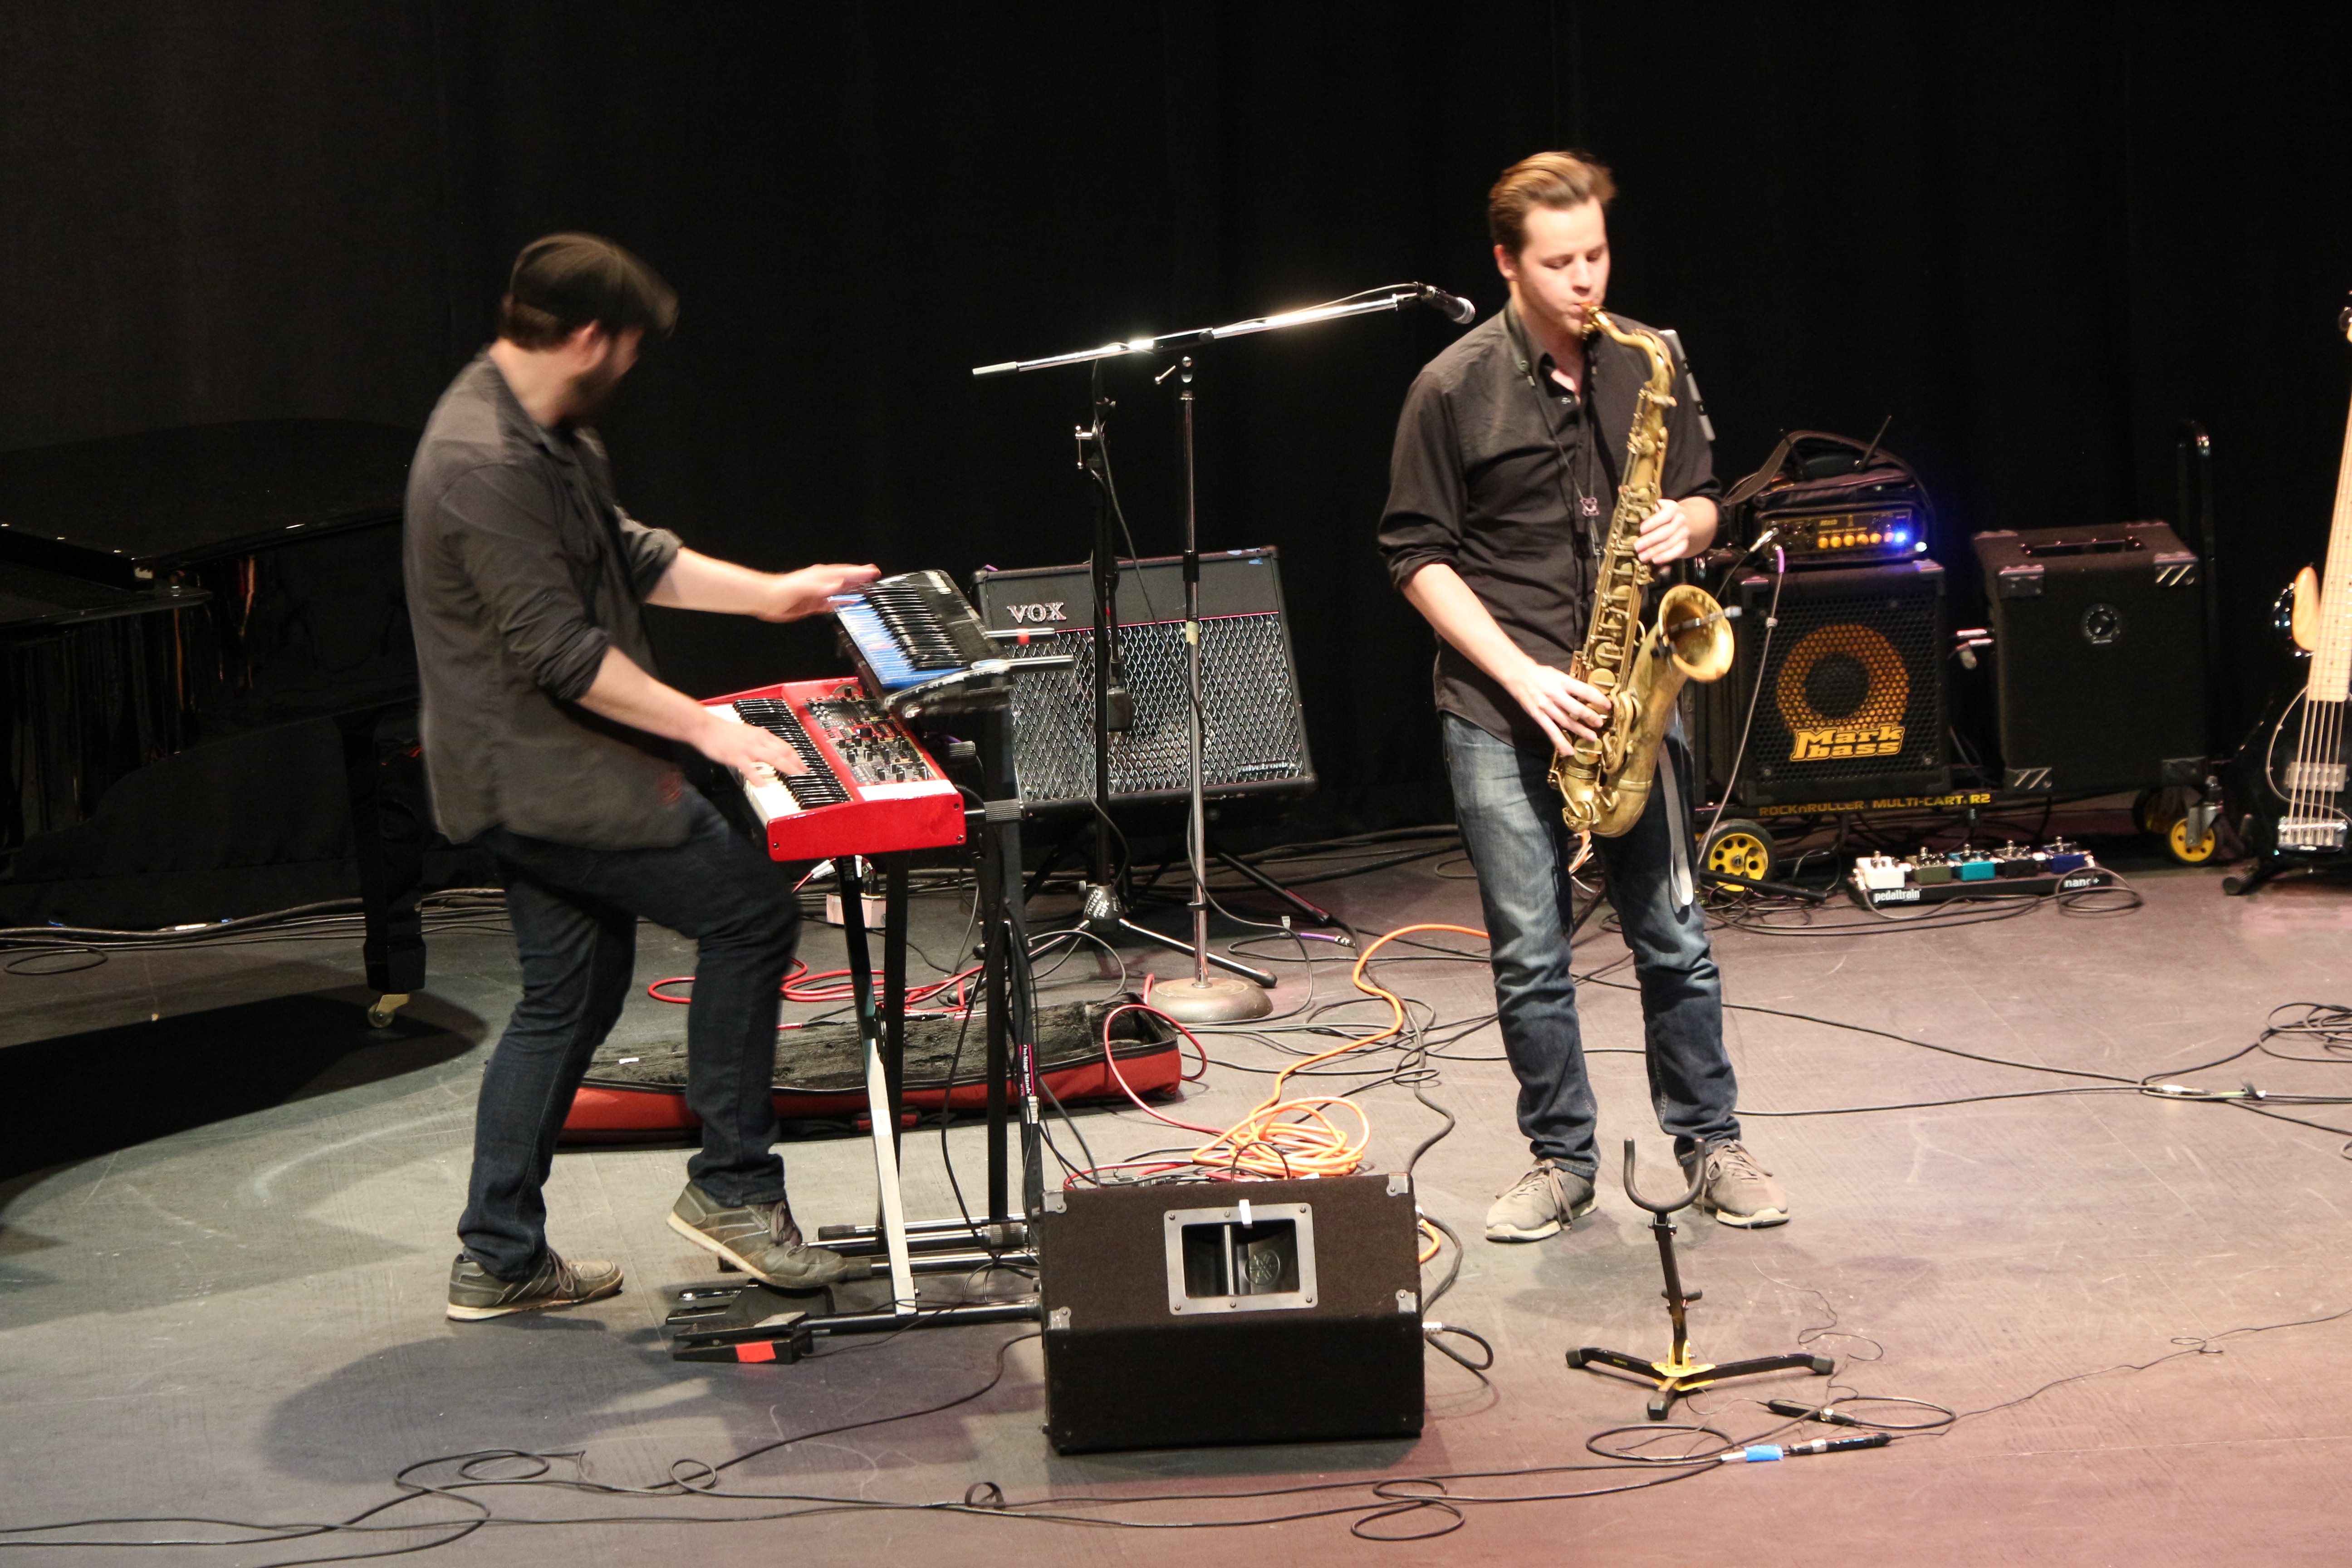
<box><xmin>971</xmin><ymin>550</ymin><xmax>1315</xmax><ymax>811</ymax></box>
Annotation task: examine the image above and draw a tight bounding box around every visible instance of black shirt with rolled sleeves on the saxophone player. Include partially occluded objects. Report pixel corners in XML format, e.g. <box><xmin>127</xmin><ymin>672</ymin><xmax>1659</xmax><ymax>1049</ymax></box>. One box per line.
<box><xmin>1381</xmin><ymin>306</ymin><xmax>1722</xmax><ymax>752</ymax></box>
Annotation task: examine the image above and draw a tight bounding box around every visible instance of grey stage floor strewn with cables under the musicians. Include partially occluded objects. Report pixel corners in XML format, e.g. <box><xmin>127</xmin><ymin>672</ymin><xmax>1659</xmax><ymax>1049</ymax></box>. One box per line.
<box><xmin>0</xmin><ymin>827</ymin><xmax>2352</xmax><ymax>1566</ymax></box>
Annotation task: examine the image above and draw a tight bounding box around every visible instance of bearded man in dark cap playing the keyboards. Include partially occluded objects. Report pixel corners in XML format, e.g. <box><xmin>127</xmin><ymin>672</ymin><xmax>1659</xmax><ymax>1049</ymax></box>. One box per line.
<box><xmin>407</xmin><ymin>235</ymin><xmax>875</xmax><ymax>1321</ymax></box>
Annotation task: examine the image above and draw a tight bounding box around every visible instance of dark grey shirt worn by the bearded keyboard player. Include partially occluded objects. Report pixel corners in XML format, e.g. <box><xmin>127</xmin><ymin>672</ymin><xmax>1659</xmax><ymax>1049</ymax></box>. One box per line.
<box><xmin>407</xmin><ymin>353</ymin><xmax>687</xmax><ymax>848</ymax></box>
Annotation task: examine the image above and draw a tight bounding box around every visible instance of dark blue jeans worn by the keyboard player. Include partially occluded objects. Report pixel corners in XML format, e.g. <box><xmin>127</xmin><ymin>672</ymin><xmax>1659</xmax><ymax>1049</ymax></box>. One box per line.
<box><xmin>456</xmin><ymin>794</ymin><xmax>800</xmax><ymax>1279</ymax></box>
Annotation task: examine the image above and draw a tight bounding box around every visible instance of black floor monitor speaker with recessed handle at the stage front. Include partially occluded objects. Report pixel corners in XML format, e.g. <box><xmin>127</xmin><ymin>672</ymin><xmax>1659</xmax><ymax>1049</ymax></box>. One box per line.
<box><xmin>1037</xmin><ymin>1176</ymin><xmax>1421</xmax><ymax>1453</ymax></box>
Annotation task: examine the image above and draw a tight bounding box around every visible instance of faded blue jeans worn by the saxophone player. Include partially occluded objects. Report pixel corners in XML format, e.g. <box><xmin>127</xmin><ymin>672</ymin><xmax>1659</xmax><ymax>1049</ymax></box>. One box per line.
<box><xmin>1440</xmin><ymin>712</ymin><xmax>1740</xmax><ymax>1176</ymax></box>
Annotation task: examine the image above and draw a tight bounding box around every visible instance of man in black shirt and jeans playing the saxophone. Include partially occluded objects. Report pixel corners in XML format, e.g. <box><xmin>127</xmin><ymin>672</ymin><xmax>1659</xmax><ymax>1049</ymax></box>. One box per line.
<box><xmin>1381</xmin><ymin>153</ymin><xmax>1788</xmax><ymax>1241</ymax></box>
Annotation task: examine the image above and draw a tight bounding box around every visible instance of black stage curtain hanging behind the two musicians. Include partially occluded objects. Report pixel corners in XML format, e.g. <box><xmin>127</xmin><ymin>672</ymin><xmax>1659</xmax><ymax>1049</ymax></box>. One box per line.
<box><xmin>0</xmin><ymin>0</ymin><xmax>2352</xmax><ymax>846</ymax></box>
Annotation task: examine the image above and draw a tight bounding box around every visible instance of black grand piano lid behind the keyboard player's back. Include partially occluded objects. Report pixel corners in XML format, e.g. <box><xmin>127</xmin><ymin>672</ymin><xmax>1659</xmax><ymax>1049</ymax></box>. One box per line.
<box><xmin>0</xmin><ymin>418</ymin><xmax>419</xmax><ymax>588</ymax></box>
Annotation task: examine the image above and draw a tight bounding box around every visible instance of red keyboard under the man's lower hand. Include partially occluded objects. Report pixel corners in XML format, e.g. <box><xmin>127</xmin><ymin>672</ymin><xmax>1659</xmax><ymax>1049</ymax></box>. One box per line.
<box><xmin>703</xmin><ymin>679</ymin><xmax>964</xmax><ymax>860</ymax></box>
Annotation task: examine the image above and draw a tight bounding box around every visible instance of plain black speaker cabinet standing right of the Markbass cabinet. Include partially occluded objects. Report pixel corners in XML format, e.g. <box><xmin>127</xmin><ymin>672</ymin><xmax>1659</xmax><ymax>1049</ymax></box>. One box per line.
<box><xmin>1976</xmin><ymin>522</ymin><xmax>2206</xmax><ymax>792</ymax></box>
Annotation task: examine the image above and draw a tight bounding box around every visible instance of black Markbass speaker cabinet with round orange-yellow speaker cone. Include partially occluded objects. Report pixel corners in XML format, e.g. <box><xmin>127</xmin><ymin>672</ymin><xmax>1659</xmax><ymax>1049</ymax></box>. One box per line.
<box><xmin>1705</xmin><ymin>559</ymin><xmax>1952</xmax><ymax>808</ymax></box>
